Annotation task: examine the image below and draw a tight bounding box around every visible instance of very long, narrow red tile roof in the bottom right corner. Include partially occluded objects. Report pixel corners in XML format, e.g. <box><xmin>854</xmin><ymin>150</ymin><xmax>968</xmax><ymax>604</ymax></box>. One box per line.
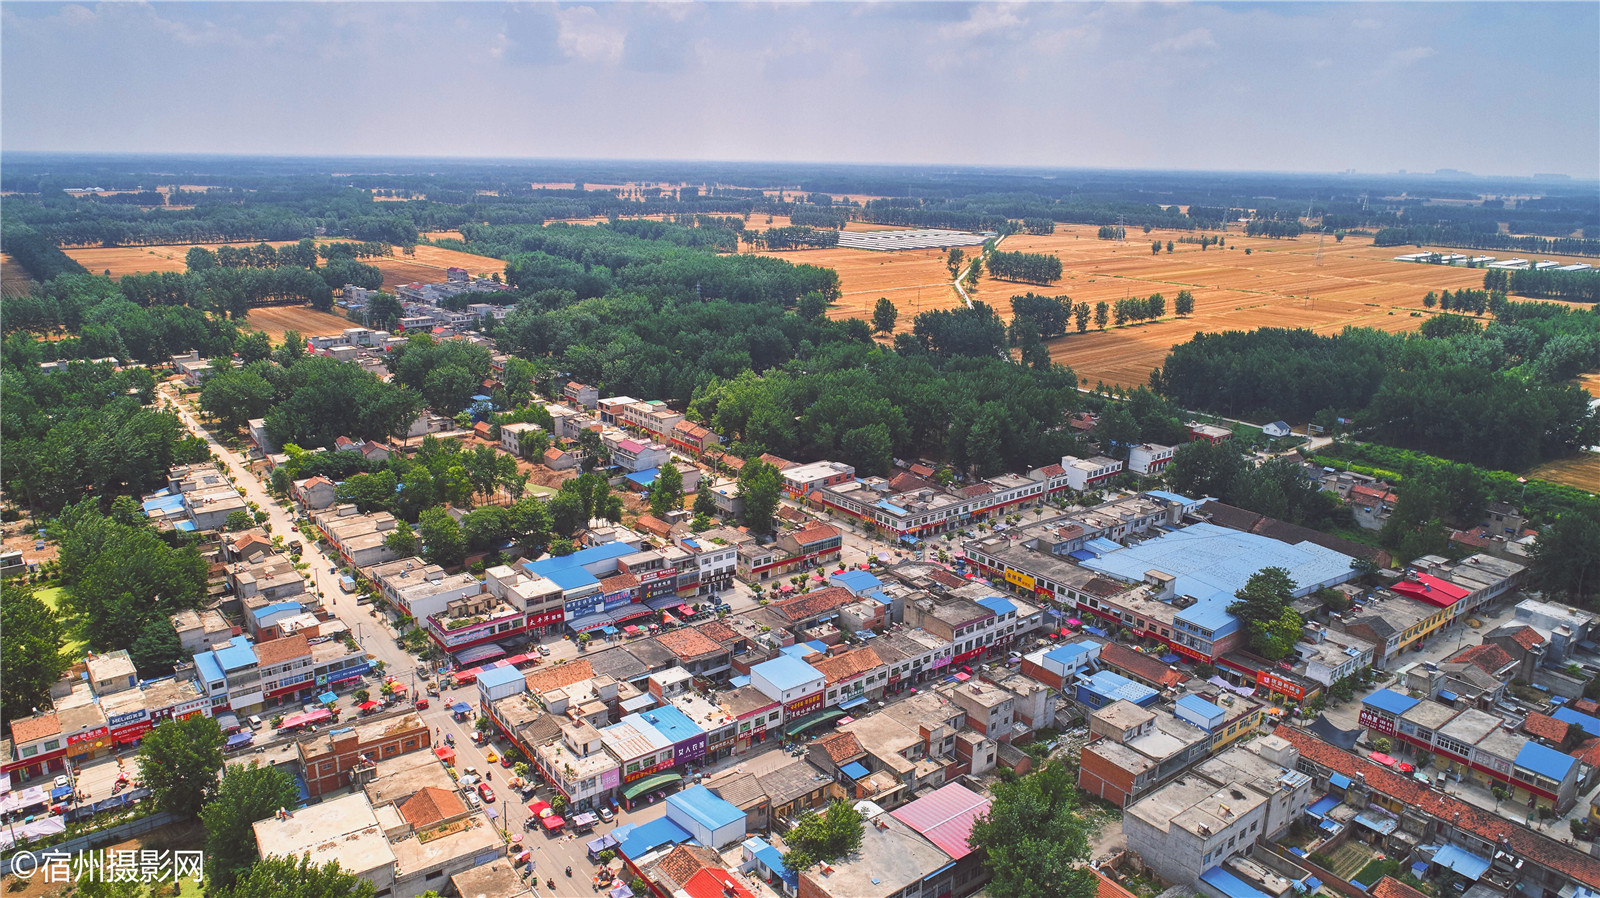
<box><xmin>1275</xmin><ymin>725</ymin><xmax>1600</xmax><ymax>888</ymax></box>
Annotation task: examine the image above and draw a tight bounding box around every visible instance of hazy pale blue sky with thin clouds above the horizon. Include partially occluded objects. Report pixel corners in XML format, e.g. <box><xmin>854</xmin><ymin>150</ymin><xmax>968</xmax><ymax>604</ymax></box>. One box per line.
<box><xmin>0</xmin><ymin>0</ymin><xmax>1600</xmax><ymax>178</ymax></box>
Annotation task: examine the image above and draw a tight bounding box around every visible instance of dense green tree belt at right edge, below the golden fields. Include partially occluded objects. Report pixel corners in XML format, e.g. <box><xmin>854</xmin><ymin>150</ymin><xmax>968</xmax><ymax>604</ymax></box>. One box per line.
<box><xmin>1150</xmin><ymin>312</ymin><xmax>1600</xmax><ymax>471</ymax></box>
